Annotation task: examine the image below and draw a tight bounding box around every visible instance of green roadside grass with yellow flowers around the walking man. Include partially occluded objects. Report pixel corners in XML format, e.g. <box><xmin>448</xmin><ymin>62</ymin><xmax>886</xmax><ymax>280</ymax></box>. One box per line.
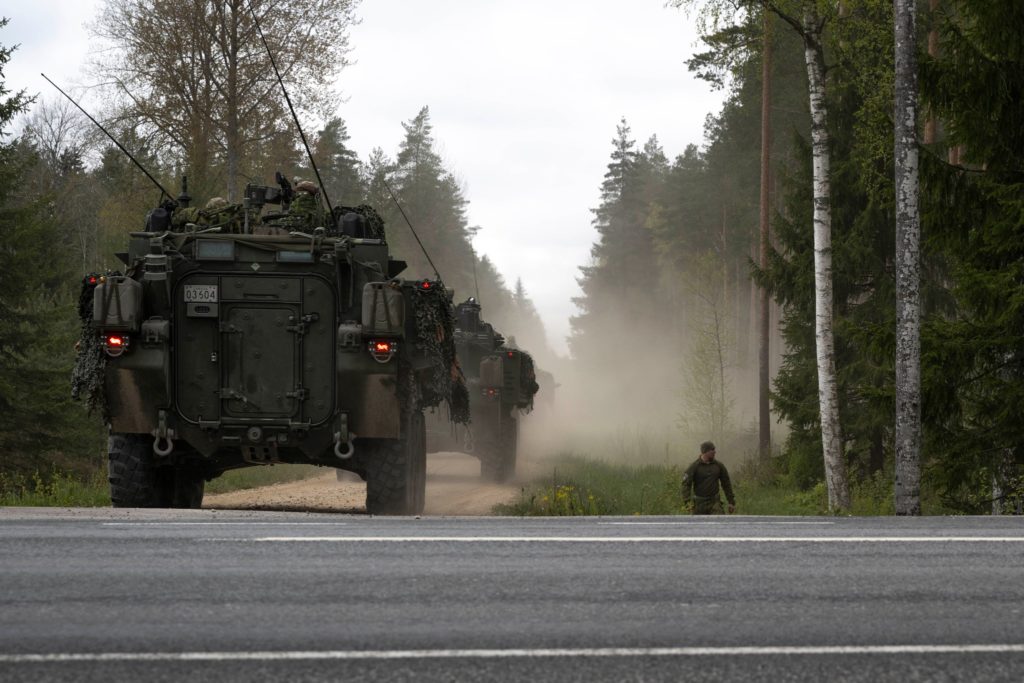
<box><xmin>494</xmin><ymin>454</ymin><xmax>949</xmax><ymax>516</ymax></box>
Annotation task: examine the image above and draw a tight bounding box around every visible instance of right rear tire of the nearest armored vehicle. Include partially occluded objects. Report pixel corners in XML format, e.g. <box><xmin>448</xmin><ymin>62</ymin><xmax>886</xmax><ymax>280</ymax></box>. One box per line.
<box><xmin>359</xmin><ymin>411</ymin><xmax>427</xmax><ymax>515</ymax></box>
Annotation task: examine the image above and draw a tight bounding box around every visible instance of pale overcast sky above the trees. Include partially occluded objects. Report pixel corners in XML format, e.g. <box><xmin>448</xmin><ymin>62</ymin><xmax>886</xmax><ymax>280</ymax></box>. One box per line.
<box><xmin>0</xmin><ymin>0</ymin><xmax>721</xmax><ymax>352</ymax></box>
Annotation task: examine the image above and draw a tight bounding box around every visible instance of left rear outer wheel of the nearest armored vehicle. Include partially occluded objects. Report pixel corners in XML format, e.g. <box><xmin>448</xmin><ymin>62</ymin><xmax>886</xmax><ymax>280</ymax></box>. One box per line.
<box><xmin>106</xmin><ymin>434</ymin><xmax>168</xmax><ymax>508</ymax></box>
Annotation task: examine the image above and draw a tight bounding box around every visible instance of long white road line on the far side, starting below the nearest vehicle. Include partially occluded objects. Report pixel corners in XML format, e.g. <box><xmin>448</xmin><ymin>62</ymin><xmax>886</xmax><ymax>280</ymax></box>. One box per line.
<box><xmin>245</xmin><ymin>536</ymin><xmax>1024</xmax><ymax>543</ymax></box>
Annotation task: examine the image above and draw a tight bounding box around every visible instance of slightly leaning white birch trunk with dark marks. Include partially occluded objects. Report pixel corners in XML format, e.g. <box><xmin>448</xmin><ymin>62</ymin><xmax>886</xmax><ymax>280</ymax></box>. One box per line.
<box><xmin>803</xmin><ymin>9</ymin><xmax>850</xmax><ymax>511</ymax></box>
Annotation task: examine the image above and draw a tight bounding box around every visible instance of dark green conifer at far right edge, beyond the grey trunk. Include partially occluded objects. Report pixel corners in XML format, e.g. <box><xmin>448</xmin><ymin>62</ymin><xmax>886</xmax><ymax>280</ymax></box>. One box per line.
<box><xmin>921</xmin><ymin>0</ymin><xmax>1024</xmax><ymax>513</ymax></box>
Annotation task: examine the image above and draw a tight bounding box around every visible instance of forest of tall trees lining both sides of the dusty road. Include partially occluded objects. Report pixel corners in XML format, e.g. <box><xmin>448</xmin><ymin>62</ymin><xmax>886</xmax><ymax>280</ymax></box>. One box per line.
<box><xmin>0</xmin><ymin>0</ymin><xmax>1024</xmax><ymax>514</ymax></box>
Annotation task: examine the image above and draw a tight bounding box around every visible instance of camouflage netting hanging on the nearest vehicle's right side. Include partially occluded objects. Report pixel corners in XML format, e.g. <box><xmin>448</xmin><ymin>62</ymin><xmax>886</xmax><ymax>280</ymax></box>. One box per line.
<box><xmin>413</xmin><ymin>283</ymin><xmax>469</xmax><ymax>424</ymax></box>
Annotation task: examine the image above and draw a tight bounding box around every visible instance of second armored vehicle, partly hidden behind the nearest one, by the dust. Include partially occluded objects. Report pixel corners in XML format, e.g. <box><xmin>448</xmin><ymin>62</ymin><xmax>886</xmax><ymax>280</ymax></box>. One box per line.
<box><xmin>427</xmin><ymin>298</ymin><xmax>539</xmax><ymax>483</ymax></box>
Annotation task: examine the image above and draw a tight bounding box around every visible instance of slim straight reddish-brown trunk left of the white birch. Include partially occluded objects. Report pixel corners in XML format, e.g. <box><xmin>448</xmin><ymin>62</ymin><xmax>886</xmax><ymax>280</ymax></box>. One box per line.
<box><xmin>758</xmin><ymin>10</ymin><xmax>772</xmax><ymax>458</ymax></box>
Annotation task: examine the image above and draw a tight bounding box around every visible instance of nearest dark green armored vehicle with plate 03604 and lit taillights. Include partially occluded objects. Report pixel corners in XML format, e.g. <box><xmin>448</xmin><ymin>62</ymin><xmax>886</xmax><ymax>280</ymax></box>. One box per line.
<box><xmin>74</xmin><ymin>174</ymin><xmax>468</xmax><ymax>514</ymax></box>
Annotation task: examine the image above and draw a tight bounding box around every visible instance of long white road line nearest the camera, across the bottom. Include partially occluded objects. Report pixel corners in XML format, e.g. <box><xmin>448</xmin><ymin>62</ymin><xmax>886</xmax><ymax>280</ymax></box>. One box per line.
<box><xmin>6</xmin><ymin>644</ymin><xmax>1024</xmax><ymax>664</ymax></box>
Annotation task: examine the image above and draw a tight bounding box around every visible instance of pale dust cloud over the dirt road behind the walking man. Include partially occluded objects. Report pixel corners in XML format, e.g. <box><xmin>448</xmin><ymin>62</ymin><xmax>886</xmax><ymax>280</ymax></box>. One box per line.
<box><xmin>520</xmin><ymin>284</ymin><xmax>786</xmax><ymax>471</ymax></box>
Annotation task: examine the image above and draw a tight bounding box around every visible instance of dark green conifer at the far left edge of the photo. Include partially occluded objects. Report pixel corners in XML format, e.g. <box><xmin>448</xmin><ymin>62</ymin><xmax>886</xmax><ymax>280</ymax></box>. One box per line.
<box><xmin>0</xmin><ymin>25</ymin><xmax>104</xmax><ymax>472</ymax></box>
